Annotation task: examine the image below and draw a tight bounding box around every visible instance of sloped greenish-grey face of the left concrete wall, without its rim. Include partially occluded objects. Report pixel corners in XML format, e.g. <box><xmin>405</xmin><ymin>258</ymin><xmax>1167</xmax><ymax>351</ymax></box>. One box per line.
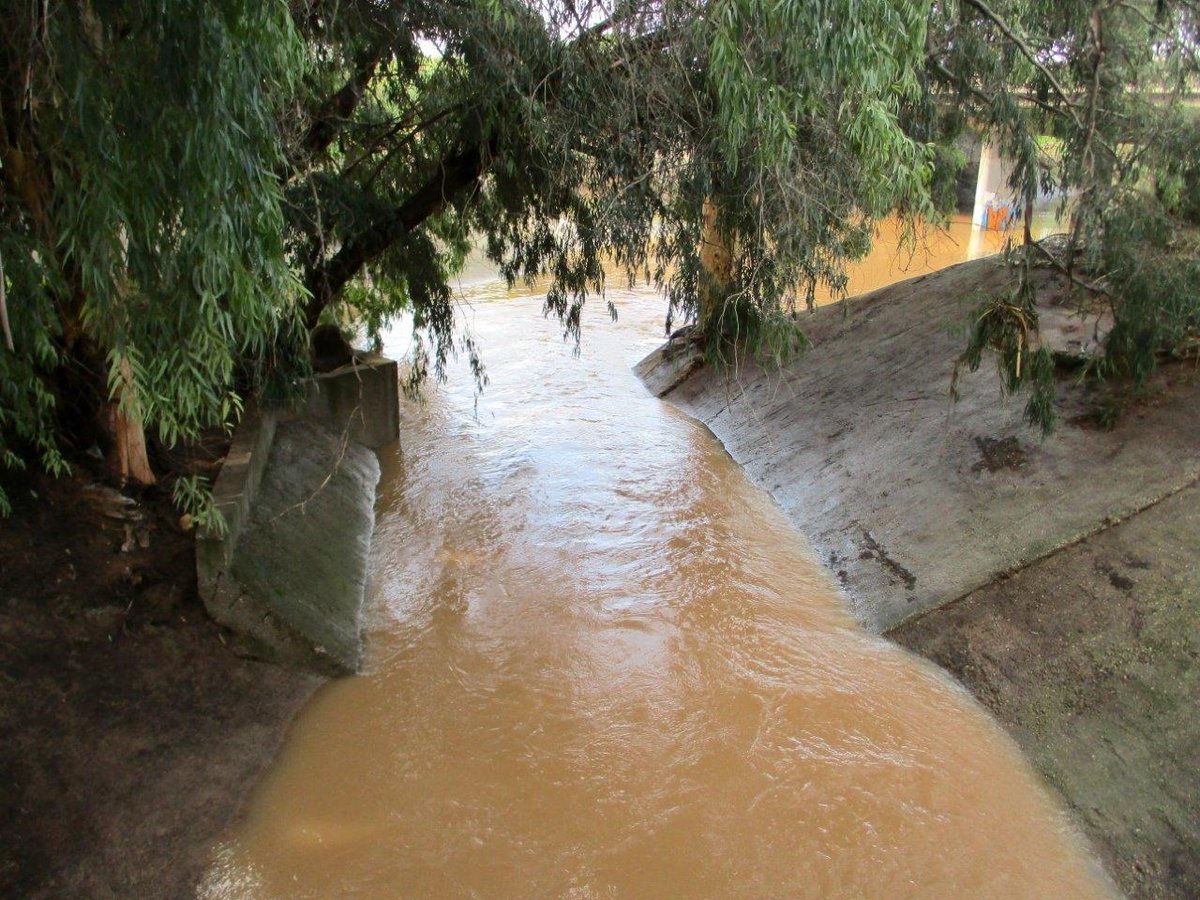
<box><xmin>229</xmin><ymin>421</ymin><xmax>379</xmax><ymax>672</ymax></box>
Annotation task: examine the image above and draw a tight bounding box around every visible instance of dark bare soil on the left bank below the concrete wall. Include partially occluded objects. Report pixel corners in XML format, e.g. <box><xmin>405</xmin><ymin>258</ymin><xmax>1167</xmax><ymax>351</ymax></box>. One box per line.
<box><xmin>0</xmin><ymin>473</ymin><xmax>320</xmax><ymax>898</ymax></box>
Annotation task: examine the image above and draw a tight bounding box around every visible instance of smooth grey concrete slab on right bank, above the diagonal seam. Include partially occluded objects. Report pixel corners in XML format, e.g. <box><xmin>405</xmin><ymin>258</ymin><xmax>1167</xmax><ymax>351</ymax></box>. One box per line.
<box><xmin>640</xmin><ymin>257</ymin><xmax>1200</xmax><ymax>631</ymax></box>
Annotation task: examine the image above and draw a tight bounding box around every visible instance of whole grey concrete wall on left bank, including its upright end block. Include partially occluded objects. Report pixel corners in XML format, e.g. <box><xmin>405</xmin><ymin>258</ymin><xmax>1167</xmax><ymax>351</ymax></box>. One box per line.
<box><xmin>196</xmin><ymin>356</ymin><xmax>400</xmax><ymax>673</ymax></box>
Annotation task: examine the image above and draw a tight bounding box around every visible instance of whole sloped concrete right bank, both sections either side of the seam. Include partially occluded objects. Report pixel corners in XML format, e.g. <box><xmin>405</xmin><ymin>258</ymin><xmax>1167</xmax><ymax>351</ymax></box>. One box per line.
<box><xmin>638</xmin><ymin>258</ymin><xmax>1200</xmax><ymax>898</ymax></box>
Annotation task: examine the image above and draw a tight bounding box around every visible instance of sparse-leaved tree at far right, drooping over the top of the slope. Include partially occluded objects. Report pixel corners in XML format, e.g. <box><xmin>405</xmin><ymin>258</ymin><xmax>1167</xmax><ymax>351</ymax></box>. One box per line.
<box><xmin>926</xmin><ymin>0</ymin><xmax>1200</xmax><ymax>431</ymax></box>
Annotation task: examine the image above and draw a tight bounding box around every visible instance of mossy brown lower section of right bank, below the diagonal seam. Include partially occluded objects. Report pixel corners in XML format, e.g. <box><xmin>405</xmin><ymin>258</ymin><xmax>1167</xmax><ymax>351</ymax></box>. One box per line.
<box><xmin>888</xmin><ymin>487</ymin><xmax>1200</xmax><ymax>898</ymax></box>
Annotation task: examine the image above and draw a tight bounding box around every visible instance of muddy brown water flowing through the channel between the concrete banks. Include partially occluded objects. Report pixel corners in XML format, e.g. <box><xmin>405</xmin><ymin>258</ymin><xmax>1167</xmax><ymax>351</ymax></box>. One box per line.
<box><xmin>203</xmin><ymin>218</ymin><xmax>1109</xmax><ymax>898</ymax></box>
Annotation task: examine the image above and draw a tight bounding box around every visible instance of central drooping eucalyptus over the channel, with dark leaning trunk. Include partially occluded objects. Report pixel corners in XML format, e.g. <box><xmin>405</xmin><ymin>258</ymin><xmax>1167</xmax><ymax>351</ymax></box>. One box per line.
<box><xmin>288</xmin><ymin>0</ymin><xmax>932</xmax><ymax>386</ymax></box>
